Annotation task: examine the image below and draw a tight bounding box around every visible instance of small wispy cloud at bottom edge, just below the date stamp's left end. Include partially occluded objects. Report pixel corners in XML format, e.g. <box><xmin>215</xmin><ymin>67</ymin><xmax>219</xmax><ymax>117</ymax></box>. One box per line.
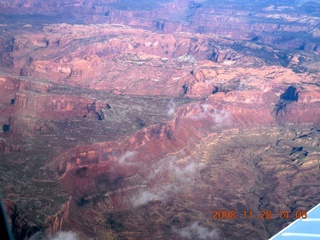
<box><xmin>172</xmin><ymin>221</ymin><xmax>219</xmax><ymax>240</ymax></box>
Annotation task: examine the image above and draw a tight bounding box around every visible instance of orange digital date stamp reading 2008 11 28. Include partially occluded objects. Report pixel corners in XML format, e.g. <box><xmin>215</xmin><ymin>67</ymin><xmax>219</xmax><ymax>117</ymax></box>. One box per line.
<box><xmin>212</xmin><ymin>210</ymin><xmax>307</xmax><ymax>220</ymax></box>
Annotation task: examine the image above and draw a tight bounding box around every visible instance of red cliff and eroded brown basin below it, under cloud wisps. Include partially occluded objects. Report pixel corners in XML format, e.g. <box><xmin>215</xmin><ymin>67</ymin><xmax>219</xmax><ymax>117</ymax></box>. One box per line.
<box><xmin>49</xmin><ymin>94</ymin><xmax>320</xmax><ymax>239</ymax></box>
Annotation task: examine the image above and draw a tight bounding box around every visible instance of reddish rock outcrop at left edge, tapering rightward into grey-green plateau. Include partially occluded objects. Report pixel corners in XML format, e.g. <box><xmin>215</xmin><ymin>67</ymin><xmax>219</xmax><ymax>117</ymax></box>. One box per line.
<box><xmin>1</xmin><ymin>77</ymin><xmax>92</xmax><ymax>136</ymax></box>
